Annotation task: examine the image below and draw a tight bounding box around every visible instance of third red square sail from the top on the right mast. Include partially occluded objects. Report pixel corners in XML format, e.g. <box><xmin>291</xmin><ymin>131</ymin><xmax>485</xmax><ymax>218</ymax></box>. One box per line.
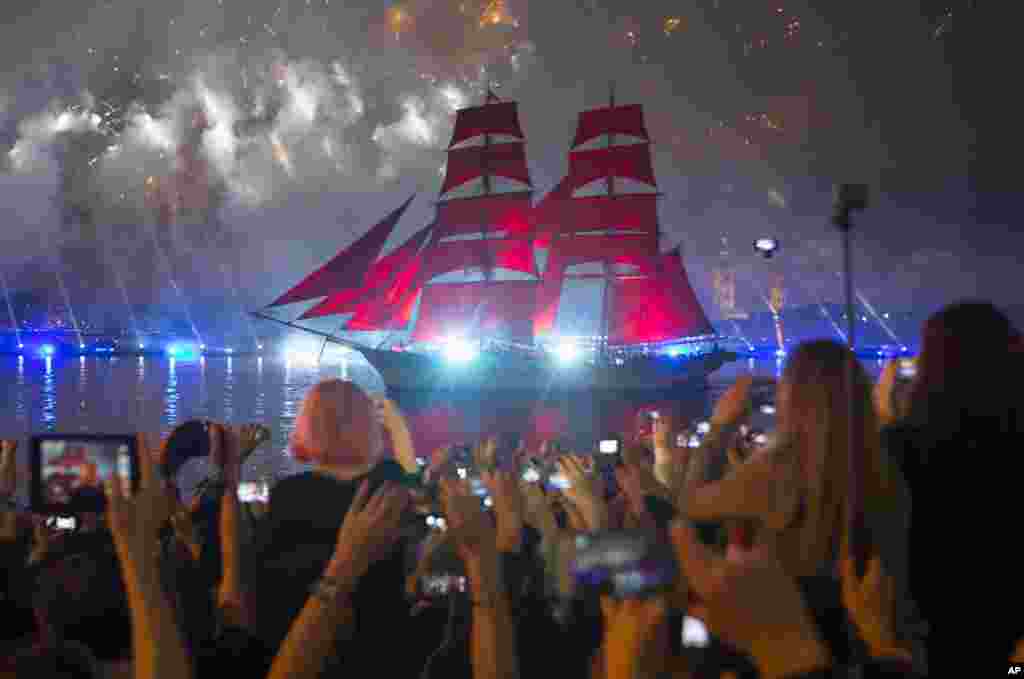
<box><xmin>545</xmin><ymin>194</ymin><xmax>657</xmax><ymax>236</ymax></box>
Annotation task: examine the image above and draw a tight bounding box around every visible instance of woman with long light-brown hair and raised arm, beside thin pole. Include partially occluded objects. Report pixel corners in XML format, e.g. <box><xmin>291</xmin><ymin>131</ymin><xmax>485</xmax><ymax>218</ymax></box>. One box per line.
<box><xmin>684</xmin><ymin>340</ymin><xmax>909</xmax><ymax>577</ymax></box>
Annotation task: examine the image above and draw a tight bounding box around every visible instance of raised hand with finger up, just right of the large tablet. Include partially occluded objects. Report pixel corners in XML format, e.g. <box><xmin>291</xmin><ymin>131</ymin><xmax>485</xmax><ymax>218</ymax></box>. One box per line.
<box><xmin>105</xmin><ymin>434</ymin><xmax>173</xmax><ymax>580</ymax></box>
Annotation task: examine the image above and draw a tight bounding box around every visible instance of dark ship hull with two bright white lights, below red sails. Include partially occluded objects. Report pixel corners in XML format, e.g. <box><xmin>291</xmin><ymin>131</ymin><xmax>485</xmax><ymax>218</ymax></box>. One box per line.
<box><xmin>362</xmin><ymin>349</ymin><xmax>738</xmax><ymax>395</ymax></box>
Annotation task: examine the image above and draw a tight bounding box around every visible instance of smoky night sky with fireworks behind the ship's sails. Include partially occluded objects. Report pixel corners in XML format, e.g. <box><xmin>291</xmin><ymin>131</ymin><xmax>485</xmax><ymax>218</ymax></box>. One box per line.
<box><xmin>0</xmin><ymin>0</ymin><xmax>1024</xmax><ymax>327</ymax></box>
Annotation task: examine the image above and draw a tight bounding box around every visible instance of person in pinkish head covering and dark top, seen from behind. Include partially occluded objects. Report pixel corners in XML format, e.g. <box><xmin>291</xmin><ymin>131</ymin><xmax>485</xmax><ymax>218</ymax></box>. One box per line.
<box><xmin>243</xmin><ymin>380</ymin><xmax>422</xmax><ymax>676</ymax></box>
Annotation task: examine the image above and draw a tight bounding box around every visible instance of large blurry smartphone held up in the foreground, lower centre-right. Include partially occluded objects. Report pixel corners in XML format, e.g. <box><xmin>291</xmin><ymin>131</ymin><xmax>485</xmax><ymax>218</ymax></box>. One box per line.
<box><xmin>570</xmin><ymin>531</ymin><xmax>679</xmax><ymax>599</ymax></box>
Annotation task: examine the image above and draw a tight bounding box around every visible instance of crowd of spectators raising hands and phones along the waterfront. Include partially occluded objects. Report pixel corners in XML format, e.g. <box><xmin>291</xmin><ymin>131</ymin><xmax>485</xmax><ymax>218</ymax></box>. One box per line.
<box><xmin>0</xmin><ymin>302</ymin><xmax>1024</xmax><ymax>679</ymax></box>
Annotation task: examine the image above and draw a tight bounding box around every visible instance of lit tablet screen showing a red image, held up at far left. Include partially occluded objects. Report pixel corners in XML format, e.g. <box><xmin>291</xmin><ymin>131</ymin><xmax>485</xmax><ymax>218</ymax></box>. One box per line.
<box><xmin>39</xmin><ymin>437</ymin><xmax>132</xmax><ymax>506</ymax></box>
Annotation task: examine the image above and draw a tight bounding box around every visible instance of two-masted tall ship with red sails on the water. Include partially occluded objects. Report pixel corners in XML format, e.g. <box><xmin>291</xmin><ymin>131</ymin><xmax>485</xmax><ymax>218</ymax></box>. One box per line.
<box><xmin>256</xmin><ymin>92</ymin><xmax>735</xmax><ymax>392</ymax></box>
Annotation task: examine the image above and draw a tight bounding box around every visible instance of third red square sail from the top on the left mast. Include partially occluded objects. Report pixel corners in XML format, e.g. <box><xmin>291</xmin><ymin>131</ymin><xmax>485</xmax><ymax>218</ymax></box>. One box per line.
<box><xmin>435</xmin><ymin>192</ymin><xmax>534</xmax><ymax>239</ymax></box>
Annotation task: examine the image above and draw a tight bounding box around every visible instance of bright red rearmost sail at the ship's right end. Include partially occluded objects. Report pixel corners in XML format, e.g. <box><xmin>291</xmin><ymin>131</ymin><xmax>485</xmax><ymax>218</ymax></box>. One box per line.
<box><xmin>609</xmin><ymin>249</ymin><xmax>714</xmax><ymax>344</ymax></box>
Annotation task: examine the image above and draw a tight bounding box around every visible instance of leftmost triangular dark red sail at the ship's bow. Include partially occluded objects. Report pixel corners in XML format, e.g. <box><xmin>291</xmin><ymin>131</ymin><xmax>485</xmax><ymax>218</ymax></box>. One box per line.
<box><xmin>270</xmin><ymin>196</ymin><xmax>415</xmax><ymax>306</ymax></box>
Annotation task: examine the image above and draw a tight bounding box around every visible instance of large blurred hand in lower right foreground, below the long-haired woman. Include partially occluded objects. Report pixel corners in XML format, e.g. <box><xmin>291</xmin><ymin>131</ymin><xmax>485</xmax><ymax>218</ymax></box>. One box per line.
<box><xmin>672</xmin><ymin>521</ymin><xmax>831</xmax><ymax>679</ymax></box>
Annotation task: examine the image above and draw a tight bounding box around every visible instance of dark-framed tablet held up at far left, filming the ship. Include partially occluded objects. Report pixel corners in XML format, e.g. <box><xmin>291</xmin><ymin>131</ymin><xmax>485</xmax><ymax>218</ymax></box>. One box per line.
<box><xmin>29</xmin><ymin>434</ymin><xmax>139</xmax><ymax>517</ymax></box>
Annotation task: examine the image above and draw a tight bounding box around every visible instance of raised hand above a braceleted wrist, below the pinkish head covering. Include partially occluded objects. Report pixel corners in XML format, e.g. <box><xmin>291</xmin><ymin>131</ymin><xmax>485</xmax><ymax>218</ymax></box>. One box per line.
<box><xmin>328</xmin><ymin>481</ymin><xmax>409</xmax><ymax>587</ymax></box>
